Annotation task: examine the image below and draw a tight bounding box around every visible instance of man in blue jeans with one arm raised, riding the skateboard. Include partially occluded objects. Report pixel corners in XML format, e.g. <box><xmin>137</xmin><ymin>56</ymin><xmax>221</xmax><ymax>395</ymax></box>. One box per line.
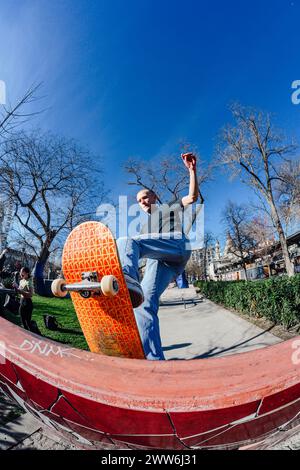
<box><xmin>117</xmin><ymin>153</ymin><xmax>198</xmax><ymax>360</ymax></box>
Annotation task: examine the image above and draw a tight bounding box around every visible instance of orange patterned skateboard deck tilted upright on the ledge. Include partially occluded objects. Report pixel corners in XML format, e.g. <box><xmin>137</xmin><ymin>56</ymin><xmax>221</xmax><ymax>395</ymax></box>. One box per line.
<box><xmin>62</xmin><ymin>222</ymin><xmax>145</xmax><ymax>359</ymax></box>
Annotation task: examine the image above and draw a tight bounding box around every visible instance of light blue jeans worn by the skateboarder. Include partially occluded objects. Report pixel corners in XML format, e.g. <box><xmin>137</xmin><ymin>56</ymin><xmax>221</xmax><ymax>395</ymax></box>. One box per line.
<box><xmin>117</xmin><ymin>237</ymin><xmax>191</xmax><ymax>360</ymax></box>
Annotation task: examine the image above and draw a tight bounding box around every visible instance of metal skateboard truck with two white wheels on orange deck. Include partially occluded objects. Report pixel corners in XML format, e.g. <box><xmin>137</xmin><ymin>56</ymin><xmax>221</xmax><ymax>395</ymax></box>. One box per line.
<box><xmin>51</xmin><ymin>271</ymin><xmax>119</xmax><ymax>299</ymax></box>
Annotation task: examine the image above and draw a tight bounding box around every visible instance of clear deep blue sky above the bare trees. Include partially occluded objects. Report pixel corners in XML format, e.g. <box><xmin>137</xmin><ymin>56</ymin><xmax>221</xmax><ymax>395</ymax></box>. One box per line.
<box><xmin>0</xmin><ymin>0</ymin><xmax>300</xmax><ymax>244</ymax></box>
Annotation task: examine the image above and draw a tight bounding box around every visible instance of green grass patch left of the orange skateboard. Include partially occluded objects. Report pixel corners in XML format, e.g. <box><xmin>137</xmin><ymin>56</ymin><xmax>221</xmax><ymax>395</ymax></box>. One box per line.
<box><xmin>5</xmin><ymin>295</ymin><xmax>89</xmax><ymax>350</ymax></box>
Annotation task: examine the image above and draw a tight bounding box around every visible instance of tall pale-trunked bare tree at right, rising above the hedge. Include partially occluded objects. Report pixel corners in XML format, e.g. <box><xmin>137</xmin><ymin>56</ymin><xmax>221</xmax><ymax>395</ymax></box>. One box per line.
<box><xmin>218</xmin><ymin>105</ymin><xmax>296</xmax><ymax>276</ymax></box>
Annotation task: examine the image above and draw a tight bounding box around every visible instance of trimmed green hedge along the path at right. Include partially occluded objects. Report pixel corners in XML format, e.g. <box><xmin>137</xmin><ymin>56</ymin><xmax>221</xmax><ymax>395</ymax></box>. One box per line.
<box><xmin>195</xmin><ymin>274</ymin><xmax>300</xmax><ymax>328</ymax></box>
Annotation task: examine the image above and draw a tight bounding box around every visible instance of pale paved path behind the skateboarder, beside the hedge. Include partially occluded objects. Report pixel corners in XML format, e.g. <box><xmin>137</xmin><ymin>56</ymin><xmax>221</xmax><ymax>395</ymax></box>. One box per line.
<box><xmin>159</xmin><ymin>287</ymin><xmax>281</xmax><ymax>360</ymax></box>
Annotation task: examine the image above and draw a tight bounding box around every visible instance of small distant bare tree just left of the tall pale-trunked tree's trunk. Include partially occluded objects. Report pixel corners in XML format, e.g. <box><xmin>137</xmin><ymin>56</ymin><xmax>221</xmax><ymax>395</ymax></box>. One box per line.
<box><xmin>222</xmin><ymin>201</ymin><xmax>256</xmax><ymax>280</ymax></box>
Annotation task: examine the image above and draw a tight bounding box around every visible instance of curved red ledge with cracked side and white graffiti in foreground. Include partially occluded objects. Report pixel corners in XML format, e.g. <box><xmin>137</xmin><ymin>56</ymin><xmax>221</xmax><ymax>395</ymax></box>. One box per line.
<box><xmin>0</xmin><ymin>318</ymin><xmax>300</xmax><ymax>450</ymax></box>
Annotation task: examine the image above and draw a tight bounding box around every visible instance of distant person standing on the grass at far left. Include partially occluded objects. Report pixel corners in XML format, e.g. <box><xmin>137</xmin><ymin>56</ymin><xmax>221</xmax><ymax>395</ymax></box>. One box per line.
<box><xmin>13</xmin><ymin>267</ymin><xmax>33</xmax><ymax>331</ymax></box>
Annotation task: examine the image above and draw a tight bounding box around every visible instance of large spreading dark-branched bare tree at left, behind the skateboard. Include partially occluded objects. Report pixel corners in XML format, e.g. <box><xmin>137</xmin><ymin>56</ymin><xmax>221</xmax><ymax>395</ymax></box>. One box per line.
<box><xmin>0</xmin><ymin>131</ymin><xmax>105</xmax><ymax>264</ymax></box>
